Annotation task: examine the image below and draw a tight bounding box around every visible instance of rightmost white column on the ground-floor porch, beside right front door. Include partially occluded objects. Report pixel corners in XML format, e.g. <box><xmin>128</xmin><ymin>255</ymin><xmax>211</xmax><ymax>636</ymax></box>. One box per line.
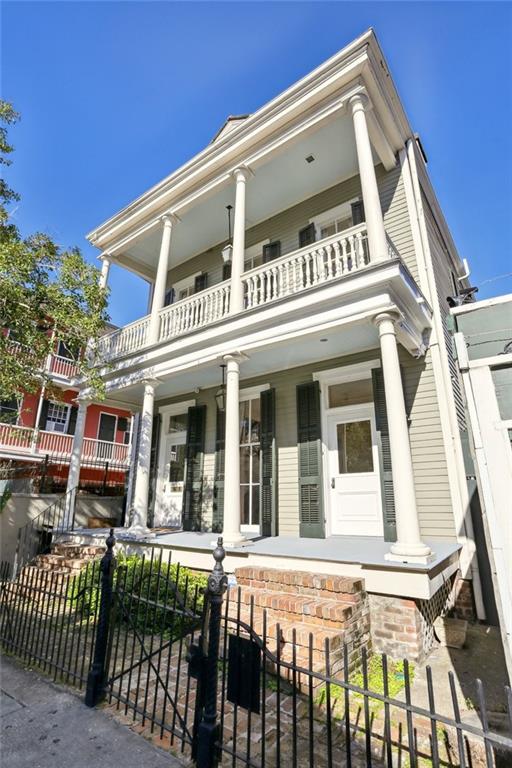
<box><xmin>375</xmin><ymin>312</ymin><xmax>431</xmax><ymax>563</ymax></box>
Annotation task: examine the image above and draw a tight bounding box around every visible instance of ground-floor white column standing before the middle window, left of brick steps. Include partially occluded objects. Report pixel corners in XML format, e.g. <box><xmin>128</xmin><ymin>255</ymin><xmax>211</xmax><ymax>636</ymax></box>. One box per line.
<box><xmin>222</xmin><ymin>355</ymin><xmax>245</xmax><ymax>547</ymax></box>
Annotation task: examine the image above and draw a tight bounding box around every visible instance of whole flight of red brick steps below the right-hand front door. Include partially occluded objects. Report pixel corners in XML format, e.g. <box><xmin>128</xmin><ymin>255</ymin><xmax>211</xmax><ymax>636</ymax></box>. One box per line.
<box><xmin>229</xmin><ymin>566</ymin><xmax>370</xmax><ymax>684</ymax></box>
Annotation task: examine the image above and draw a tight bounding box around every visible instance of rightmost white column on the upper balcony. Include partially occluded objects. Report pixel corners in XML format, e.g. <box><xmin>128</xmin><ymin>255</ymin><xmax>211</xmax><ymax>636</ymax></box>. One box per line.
<box><xmin>349</xmin><ymin>93</ymin><xmax>388</xmax><ymax>261</ymax></box>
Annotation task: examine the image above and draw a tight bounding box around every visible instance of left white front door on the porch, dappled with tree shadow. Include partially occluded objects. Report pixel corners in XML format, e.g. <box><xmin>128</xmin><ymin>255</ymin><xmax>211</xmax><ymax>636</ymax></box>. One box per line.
<box><xmin>153</xmin><ymin>432</ymin><xmax>186</xmax><ymax>528</ymax></box>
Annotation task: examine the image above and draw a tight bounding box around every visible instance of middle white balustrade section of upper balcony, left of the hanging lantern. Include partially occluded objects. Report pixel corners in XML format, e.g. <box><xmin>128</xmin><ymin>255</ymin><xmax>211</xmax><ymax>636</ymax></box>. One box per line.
<box><xmin>158</xmin><ymin>281</ymin><xmax>230</xmax><ymax>342</ymax></box>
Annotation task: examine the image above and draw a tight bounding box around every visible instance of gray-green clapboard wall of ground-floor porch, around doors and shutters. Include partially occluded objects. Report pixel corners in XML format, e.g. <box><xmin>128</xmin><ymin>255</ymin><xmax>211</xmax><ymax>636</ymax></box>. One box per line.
<box><xmin>157</xmin><ymin>350</ymin><xmax>455</xmax><ymax>540</ymax></box>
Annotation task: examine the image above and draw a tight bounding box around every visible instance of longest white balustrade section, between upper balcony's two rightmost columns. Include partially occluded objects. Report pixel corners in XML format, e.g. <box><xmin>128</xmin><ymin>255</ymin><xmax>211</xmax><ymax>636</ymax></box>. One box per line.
<box><xmin>243</xmin><ymin>224</ymin><xmax>370</xmax><ymax>309</ymax></box>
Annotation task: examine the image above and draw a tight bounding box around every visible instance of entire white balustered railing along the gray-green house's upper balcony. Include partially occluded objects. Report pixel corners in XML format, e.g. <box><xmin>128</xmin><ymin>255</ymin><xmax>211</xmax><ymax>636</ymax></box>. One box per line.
<box><xmin>99</xmin><ymin>224</ymin><xmax>388</xmax><ymax>360</ymax></box>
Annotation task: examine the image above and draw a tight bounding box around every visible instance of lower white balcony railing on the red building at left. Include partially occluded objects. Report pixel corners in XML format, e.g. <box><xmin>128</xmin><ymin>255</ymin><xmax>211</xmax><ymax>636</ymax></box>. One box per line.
<box><xmin>0</xmin><ymin>424</ymin><xmax>130</xmax><ymax>466</ymax></box>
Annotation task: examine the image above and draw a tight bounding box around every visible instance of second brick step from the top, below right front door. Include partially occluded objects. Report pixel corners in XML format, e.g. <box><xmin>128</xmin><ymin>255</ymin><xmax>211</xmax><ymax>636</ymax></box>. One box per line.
<box><xmin>229</xmin><ymin>586</ymin><xmax>354</xmax><ymax>625</ymax></box>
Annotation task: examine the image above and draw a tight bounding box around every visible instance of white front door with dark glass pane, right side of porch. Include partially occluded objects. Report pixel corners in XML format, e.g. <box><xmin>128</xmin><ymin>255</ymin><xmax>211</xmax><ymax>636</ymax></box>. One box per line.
<box><xmin>326</xmin><ymin>403</ymin><xmax>384</xmax><ymax>536</ymax></box>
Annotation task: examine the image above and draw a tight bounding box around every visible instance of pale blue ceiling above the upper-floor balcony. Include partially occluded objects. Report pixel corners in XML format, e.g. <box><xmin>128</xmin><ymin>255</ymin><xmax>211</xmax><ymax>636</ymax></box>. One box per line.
<box><xmin>120</xmin><ymin>115</ymin><xmax>358</xmax><ymax>275</ymax></box>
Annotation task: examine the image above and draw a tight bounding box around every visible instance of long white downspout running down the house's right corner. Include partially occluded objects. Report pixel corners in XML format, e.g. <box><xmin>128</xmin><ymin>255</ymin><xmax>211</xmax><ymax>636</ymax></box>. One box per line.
<box><xmin>400</xmin><ymin>139</ymin><xmax>485</xmax><ymax>620</ymax></box>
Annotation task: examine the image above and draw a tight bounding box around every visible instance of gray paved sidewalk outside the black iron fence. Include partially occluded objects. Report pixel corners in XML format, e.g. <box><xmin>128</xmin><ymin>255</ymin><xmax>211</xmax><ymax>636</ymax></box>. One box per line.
<box><xmin>0</xmin><ymin>656</ymin><xmax>181</xmax><ymax>768</ymax></box>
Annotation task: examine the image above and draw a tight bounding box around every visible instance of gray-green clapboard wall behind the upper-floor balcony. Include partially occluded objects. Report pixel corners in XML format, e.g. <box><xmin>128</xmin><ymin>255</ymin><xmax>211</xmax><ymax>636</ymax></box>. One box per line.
<box><xmin>167</xmin><ymin>165</ymin><xmax>417</xmax><ymax>286</ymax></box>
